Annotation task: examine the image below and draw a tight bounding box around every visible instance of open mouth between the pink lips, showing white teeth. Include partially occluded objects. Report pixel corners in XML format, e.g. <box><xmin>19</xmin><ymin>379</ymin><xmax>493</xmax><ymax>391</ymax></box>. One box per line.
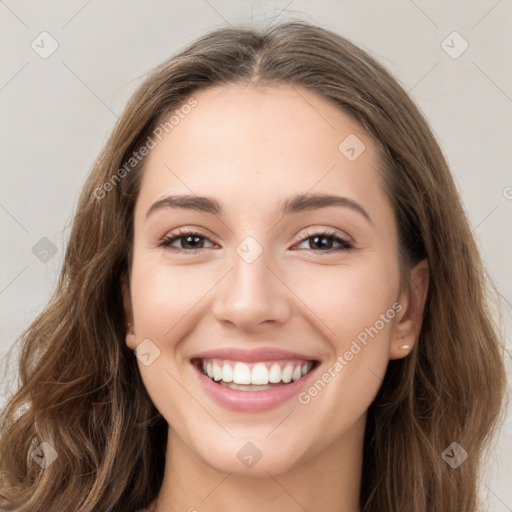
<box><xmin>192</xmin><ymin>358</ymin><xmax>318</xmax><ymax>391</ymax></box>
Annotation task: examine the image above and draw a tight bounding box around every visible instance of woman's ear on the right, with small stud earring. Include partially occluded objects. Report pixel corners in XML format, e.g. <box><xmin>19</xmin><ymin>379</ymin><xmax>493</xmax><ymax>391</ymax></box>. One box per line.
<box><xmin>389</xmin><ymin>260</ymin><xmax>429</xmax><ymax>359</ymax></box>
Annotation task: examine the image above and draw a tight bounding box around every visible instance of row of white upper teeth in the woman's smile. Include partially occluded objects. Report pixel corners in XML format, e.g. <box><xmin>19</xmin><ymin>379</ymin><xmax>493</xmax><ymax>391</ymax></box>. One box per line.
<box><xmin>202</xmin><ymin>359</ymin><xmax>313</xmax><ymax>385</ymax></box>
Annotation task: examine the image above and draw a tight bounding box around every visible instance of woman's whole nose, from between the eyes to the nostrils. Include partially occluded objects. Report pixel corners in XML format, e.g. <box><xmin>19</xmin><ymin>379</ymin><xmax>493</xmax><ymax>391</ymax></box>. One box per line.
<box><xmin>213</xmin><ymin>237</ymin><xmax>290</xmax><ymax>329</ymax></box>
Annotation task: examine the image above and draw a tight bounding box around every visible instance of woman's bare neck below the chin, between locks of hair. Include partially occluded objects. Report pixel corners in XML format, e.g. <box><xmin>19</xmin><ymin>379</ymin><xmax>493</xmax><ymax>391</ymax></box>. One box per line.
<box><xmin>156</xmin><ymin>418</ymin><xmax>365</xmax><ymax>512</ymax></box>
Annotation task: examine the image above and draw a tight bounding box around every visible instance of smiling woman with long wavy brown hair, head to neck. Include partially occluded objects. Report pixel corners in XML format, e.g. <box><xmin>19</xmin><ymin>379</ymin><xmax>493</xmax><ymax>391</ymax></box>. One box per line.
<box><xmin>0</xmin><ymin>22</ymin><xmax>504</xmax><ymax>512</ymax></box>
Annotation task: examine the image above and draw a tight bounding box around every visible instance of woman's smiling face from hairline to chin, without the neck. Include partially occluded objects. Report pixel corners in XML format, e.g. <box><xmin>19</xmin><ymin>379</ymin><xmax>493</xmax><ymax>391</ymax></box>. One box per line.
<box><xmin>125</xmin><ymin>85</ymin><xmax>424</xmax><ymax>475</ymax></box>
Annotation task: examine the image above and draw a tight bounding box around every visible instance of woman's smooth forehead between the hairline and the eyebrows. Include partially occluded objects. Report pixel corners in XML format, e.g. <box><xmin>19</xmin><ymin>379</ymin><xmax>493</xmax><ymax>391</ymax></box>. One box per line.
<box><xmin>134</xmin><ymin>84</ymin><xmax>390</xmax><ymax>224</ymax></box>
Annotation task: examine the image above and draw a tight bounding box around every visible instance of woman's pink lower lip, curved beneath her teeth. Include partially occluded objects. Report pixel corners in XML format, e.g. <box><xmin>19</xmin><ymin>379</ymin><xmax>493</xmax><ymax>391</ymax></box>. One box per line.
<box><xmin>192</xmin><ymin>365</ymin><xmax>315</xmax><ymax>412</ymax></box>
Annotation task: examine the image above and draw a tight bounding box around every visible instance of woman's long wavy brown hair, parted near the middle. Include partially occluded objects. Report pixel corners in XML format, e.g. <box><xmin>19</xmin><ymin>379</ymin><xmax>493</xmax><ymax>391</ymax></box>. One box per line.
<box><xmin>0</xmin><ymin>22</ymin><xmax>505</xmax><ymax>512</ymax></box>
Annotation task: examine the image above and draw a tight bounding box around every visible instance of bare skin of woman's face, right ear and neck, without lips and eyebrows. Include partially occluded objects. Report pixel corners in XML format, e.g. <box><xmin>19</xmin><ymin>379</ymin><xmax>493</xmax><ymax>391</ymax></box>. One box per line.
<box><xmin>125</xmin><ymin>85</ymin><xmax>428</xmax><ymax>512</ymax></box>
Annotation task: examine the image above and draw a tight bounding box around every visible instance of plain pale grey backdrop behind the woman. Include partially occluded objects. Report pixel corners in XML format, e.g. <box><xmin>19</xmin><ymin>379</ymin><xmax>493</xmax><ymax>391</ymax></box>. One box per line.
<box><xmin>0</xmin><ymin>0</ymin><xmax>512</xmax><ymax>512</ymax></box>
